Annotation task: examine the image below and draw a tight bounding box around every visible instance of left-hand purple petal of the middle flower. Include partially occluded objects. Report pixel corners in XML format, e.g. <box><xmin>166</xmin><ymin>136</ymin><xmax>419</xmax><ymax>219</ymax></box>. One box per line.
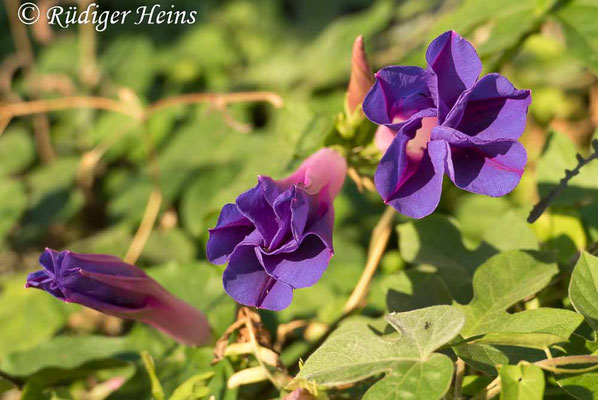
<box><xmin>206</xmin><ymin>204</ymin><xmax>254</xmax><ymax>264</ymax></box>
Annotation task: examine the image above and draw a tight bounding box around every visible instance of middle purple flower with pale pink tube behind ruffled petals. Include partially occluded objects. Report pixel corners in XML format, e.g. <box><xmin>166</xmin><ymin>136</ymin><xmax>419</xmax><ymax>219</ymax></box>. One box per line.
<box><xmin>207</xmin><ymin>148</ymin><xmax>347</xmax><ymax>311</ymax></box>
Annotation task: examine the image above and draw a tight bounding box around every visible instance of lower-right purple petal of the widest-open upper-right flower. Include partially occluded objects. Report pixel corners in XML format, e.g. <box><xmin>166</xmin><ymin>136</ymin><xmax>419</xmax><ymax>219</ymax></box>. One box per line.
<box><xmin>447</xmin><ymin>136</ymin><xmax>527</xmax><ymax>197</ymax></box>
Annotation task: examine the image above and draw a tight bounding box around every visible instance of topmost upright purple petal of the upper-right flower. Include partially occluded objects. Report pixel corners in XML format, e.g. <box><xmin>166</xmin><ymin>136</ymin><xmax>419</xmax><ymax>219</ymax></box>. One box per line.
<box><xmin>426</xmin><ymin>31</ymin><xmax>482</xmax><ymax>123</ymax></box>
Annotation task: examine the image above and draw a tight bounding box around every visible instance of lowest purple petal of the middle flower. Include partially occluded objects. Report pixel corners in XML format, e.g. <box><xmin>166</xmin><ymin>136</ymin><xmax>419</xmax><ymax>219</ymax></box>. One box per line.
<box><xmin>222</xmin><ymin>246</ymin><xmax>293</xmax><ymax>311</ymax></box>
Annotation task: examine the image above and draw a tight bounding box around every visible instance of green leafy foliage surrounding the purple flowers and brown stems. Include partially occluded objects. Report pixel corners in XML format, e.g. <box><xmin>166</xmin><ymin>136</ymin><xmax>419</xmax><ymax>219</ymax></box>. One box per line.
<box><xmin>0</xmin><ymin>0</ymin><xmax>598</xmax><ymax>400</ymax></box>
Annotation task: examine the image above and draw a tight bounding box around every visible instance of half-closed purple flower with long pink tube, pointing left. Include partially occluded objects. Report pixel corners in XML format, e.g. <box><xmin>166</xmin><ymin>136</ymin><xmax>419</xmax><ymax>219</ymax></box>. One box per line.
<box><xmin>25</xmin><ymin>249</ymin><xmax>210</xmax><ymax>346</ymax></box>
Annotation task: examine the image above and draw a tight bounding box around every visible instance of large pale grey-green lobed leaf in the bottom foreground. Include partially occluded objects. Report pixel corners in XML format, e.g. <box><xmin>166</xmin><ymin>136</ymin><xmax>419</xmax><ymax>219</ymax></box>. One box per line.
<box><xmin>294</xmin><ymin>306</ymin><xmax>465</xmax><ymax>399</ymax></box>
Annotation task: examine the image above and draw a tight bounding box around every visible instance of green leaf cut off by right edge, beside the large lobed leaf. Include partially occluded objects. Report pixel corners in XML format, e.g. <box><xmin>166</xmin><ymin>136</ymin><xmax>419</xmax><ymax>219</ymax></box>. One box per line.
<box><xmin>569</xmin><ymin>251</ymin><xmax>598</xmax><ymax>331</ymax></box>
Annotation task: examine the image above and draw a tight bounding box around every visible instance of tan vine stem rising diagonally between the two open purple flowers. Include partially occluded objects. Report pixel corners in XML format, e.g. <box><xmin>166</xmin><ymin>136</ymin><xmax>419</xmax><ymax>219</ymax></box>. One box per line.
<box><xmin>343</xmin><ymin>207</ymin><xmax>396</xmax><ymax>315</ymax></box>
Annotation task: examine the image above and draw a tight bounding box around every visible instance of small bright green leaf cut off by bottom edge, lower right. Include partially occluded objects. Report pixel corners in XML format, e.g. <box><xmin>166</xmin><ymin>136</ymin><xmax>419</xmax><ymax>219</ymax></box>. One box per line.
<box><xmin>500</xmin><ymin>364</ymin><xmax>545</xmax><ymax>400</ymax></box>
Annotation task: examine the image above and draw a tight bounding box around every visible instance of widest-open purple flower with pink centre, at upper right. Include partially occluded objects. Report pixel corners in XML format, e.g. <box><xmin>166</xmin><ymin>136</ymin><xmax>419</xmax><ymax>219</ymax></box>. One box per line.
<box><xmin>363</xmin><ymin>31</ymin><xmax>531</xmax><ymax>218</ymax></box>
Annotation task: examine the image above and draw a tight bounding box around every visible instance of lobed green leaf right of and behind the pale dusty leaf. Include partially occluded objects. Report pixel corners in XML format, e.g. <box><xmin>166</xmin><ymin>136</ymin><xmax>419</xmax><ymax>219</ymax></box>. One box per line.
<box><xmin>454</xmin><ymin>251</ymin><xmax>582</xmax><ymax>374</ymax></box>
